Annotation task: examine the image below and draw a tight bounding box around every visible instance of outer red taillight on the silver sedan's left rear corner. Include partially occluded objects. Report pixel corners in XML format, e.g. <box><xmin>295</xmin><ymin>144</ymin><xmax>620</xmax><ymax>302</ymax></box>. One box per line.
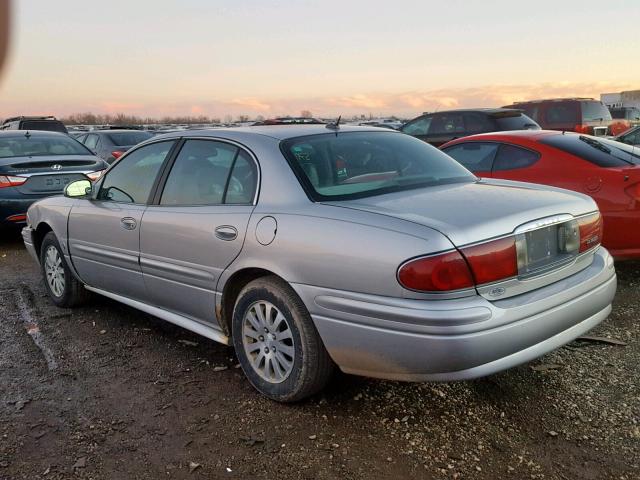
<box><xmin>398</xmin><ymin>251</ymin><xmax>474</xmax><ymax>292</ymax></box>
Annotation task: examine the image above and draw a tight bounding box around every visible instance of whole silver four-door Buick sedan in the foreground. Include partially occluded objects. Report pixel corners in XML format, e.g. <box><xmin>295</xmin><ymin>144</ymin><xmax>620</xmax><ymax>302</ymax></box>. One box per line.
<box><xmin>23</xmin><ymin>125</ymin><xmax>616</xmax><ymax>401</ymax></box>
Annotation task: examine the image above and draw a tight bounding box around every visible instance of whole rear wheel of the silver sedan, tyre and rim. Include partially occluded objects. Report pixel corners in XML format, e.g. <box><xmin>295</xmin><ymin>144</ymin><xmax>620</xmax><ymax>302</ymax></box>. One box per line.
<box><xmin>232</xmin><ymin>276</ymin><xmax>334</xmax><ymax>402</ymax></box>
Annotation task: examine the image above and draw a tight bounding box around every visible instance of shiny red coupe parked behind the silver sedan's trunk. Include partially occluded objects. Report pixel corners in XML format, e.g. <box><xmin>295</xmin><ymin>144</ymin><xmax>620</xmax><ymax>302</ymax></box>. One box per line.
<box><xmin>441</xmin><ymin>130</ymin><xmax>640</xmax><ymax>259</ymax></box>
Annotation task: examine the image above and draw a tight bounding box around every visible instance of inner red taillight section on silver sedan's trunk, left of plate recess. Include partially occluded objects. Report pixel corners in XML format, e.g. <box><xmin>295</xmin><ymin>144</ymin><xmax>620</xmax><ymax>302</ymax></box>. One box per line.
<box><xmin>462</xmin><ymin>237</ymin><xmax>518</xmax><ymax>285</ymax></box>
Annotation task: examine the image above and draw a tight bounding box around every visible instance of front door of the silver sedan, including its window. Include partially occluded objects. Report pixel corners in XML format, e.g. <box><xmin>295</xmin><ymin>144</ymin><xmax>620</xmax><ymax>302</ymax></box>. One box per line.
<box><xmin>68</xmin><ymin>141</ymin><xmax>175</xmax><ymax>300</ymax></box>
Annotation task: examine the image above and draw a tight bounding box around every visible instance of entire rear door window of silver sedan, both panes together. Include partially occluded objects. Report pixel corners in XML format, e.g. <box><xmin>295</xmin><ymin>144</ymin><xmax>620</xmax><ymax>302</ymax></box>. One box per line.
<box><xmin>160</xmin><ymin>140</ymin><xmax>256</xmax><ymax>205</ymax></box>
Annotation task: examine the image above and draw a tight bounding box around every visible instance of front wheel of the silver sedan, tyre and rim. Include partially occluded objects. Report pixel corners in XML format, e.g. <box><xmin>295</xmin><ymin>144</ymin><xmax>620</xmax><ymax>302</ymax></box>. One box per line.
<box><xmin>40</xmin><ymin>232</ymin><xmax>89</xmax><ymax>308</ymax></box>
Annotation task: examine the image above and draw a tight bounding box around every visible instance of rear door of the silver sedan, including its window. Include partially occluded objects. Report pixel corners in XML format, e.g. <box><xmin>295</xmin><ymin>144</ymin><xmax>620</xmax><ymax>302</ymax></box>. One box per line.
<box><xmin>140</xmin><ymin>139</ymin><xmax>258</xmax><ymax>322</ymax></box>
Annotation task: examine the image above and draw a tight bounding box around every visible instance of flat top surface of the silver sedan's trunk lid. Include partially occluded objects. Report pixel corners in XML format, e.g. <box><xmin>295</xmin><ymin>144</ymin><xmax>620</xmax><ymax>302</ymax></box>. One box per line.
<box><xmin>328</xmin><ymin>179</ymin><xmax>598</xmax><ymax>246</ymax></box>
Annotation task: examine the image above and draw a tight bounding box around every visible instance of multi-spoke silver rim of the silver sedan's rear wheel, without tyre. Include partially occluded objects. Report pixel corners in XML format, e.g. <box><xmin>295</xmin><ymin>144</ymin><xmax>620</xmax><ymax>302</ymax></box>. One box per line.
<box><xmin>242</xmin><ymin>300</ymin><xmax>295</xmax><ymax>383</ymax></box>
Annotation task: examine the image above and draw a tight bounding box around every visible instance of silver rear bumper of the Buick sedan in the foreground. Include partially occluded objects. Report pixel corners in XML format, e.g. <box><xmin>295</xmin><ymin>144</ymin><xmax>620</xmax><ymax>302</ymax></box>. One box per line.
<box><xmin>294</xmin><ymin>248</ymin><xmax>616</xmax><ymax>381</ymax></box>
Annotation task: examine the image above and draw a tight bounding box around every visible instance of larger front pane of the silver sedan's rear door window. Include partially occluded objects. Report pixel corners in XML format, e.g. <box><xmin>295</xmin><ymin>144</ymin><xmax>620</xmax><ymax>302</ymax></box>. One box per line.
<box><xmin>160</xmin><ymin>140</ymin><xmax>241</xmax><ymax>205</ymax></box>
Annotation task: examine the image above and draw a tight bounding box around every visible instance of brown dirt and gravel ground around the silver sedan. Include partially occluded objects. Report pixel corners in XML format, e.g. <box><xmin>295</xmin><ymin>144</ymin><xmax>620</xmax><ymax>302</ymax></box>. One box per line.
<box><xmin>0</xmin><ymin>231</ymin><xmax>640</xmax><ymax>480</ymax></box>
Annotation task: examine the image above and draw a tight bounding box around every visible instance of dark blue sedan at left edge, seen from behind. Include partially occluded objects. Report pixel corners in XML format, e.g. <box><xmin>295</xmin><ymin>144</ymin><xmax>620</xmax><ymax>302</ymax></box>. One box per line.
<box><xmin>0</xmin><ymin>130</ymin><xmax>108</xmax><ymax>226</ymax></box>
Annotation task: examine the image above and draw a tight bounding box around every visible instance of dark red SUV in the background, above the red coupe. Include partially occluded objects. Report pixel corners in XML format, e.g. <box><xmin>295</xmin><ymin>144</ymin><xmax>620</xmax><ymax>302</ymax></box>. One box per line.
<box><xmin>505</xmin><ymin>98</ymin><xmax>629</xmax><ymax>136</ymax></box>
